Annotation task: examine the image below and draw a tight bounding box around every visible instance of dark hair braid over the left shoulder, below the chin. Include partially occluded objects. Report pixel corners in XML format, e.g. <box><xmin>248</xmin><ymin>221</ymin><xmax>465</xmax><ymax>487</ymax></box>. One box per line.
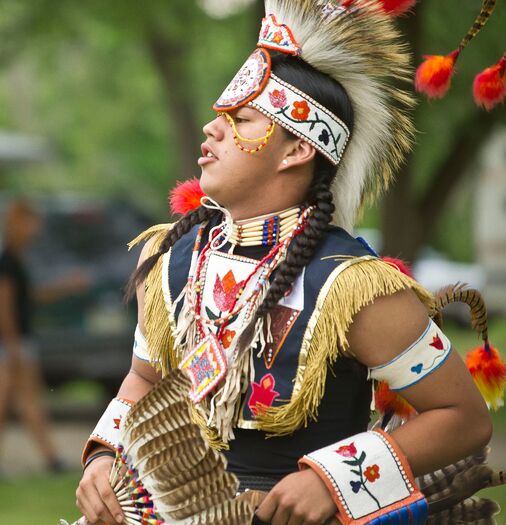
<box><xmin>125</xmin><ymin>206</ymin><xmax>221</xmax><ymax>300</ymax></box>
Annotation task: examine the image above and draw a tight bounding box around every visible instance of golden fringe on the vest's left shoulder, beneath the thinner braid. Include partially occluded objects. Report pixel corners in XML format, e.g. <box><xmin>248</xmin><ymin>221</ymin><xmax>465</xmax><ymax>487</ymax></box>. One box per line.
<box><xmin>128</xmin><ymin>224</ymin><xmax>177</xmax><ymax>375</ymax></box>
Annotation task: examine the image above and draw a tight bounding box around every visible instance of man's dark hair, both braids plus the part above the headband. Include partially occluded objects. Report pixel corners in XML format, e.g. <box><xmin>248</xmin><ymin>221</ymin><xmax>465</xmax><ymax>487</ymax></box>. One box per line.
<box><xmin>127</xmin><ymin>52</ymin><xmax>353</xmax><ymax>312</ymax></box>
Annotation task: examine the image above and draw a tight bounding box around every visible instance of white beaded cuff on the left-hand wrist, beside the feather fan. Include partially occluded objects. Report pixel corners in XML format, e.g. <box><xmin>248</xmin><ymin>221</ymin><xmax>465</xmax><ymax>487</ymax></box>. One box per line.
<box><xmin>81</xmin><ymin>397</ymin><xmax>133</xmax><ymax>465</ymax></box>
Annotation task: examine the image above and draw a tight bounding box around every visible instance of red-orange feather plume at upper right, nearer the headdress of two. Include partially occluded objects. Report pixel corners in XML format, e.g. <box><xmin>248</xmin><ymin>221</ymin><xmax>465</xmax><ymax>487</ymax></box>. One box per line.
<box><xmin>415</xmin><ymin>49</ymin><xmax>460</xmax><ymax>98</ymax></box>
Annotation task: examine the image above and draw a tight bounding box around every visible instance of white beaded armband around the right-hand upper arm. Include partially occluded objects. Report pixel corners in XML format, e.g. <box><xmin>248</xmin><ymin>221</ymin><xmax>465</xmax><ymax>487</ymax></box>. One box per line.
<box><xmin>369</xmin><ymin>320</ymin><xmax>451</xmax><ymax>390</ymax></box>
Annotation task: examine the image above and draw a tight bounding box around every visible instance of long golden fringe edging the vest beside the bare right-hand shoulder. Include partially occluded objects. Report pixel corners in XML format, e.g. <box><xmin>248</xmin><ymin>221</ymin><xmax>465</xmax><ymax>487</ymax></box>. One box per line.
<box><xmin>258</xmin><ymin>257</ymin><xmax>434</xmax><ymax>436</ymax></box>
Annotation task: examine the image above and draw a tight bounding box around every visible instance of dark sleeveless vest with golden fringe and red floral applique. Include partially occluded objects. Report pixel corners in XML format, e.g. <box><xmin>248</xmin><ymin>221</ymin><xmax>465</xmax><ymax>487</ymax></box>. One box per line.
<box><xmin>126</xmin><ymin>219</ymin><xmax>433</xmax><ymax>520</ymax></box>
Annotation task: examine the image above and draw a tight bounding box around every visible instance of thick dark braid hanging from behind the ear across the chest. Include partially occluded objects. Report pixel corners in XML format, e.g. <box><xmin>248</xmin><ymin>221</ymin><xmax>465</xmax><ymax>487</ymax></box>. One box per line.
<box><xmin>256</xmin><ymin>177</ymin><xmax>335</xmax><ymax>319</ymax></box>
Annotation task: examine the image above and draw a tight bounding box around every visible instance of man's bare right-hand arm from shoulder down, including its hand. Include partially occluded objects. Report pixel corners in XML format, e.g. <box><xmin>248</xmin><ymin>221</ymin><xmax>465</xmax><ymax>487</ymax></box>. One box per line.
<box><xmin>257</xmin><ymin>290</ymin><xmax>491</xmax><ymax>525</ymax></box>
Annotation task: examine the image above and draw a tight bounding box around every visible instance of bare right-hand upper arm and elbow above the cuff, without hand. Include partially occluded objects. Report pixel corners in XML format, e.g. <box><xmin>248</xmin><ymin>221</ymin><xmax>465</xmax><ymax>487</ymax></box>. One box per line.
<box><xmin>348</xmin><ymin>290</ymin><xmax>492</xmax><ymax>476</ymax></box>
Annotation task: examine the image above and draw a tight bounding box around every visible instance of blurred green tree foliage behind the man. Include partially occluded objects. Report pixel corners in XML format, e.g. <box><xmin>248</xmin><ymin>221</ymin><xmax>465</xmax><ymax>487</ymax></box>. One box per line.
<box><xmin>0</xmin><ymin>0</ymin><xmax>506</xmax><ymax>260</ymax></box>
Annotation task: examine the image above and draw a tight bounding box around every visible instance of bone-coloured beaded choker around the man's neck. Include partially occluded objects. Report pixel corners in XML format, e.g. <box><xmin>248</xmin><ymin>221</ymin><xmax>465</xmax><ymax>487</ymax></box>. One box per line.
<box><xmin>229</xmin><ymin>206</ymin><xmax>304</xmax><ymax>246</ymax></box>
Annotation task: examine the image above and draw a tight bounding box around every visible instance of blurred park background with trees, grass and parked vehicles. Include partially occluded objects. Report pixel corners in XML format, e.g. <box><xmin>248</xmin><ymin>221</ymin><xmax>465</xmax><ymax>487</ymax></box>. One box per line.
<box><xmin>0</xmin><ymin>0</ymin><xmax>506</xmax><ymax>525</ymax></box>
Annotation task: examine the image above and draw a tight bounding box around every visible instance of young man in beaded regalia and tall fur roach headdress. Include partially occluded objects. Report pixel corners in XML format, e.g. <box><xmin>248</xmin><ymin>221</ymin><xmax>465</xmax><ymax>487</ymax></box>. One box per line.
<box><xmin>77</xmin><ymin>0</ymin><xmax>491</xmax><ymax>525</ymax></box>
